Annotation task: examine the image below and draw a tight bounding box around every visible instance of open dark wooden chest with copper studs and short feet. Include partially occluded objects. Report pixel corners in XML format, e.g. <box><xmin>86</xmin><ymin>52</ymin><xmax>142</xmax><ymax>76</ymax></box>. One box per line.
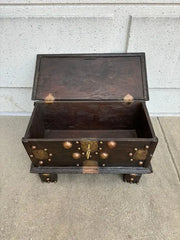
<box><xmin>22</xmin><ymin>53</ymin><xmax>158</xmax><ymax>183</ymax></box>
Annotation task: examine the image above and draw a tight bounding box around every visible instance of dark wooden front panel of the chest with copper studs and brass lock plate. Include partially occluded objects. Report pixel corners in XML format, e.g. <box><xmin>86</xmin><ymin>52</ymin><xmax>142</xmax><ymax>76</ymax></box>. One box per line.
<box><xmin>23</xmin><ymin>139</ymin><xmax>156</xmax><ymax>168</ymax></box>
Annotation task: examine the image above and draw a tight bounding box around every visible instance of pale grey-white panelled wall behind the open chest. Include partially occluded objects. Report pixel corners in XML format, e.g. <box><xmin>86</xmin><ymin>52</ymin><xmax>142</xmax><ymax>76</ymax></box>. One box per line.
<box><xmin>0</xmin><ymin>0</ymin><xmax>180</xmax><ymax>115</ymax></box>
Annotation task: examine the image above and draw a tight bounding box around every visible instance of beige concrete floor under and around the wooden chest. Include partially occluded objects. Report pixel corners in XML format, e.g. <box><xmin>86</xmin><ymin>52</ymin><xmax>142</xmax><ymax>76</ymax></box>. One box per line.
<box><xmin>0</xmin><ymin>117</ymin><xmax>180</xmax><ymax>240</ymax></box>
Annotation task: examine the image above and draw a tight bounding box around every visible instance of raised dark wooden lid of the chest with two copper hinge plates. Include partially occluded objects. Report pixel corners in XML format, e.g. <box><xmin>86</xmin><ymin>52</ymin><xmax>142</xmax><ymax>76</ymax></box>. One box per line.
<box><xmin>32</xmin><ymin>53</ymin><xmax>149</xmax><ymax>102</ymax></box>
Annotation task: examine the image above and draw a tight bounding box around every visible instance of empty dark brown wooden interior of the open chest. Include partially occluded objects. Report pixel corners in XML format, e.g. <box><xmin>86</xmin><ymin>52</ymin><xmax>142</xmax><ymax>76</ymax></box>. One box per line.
<box><xmin>26</xmin><ymin>101</ymin><xmax>153</xmax><ymax>139</ymax></box>
